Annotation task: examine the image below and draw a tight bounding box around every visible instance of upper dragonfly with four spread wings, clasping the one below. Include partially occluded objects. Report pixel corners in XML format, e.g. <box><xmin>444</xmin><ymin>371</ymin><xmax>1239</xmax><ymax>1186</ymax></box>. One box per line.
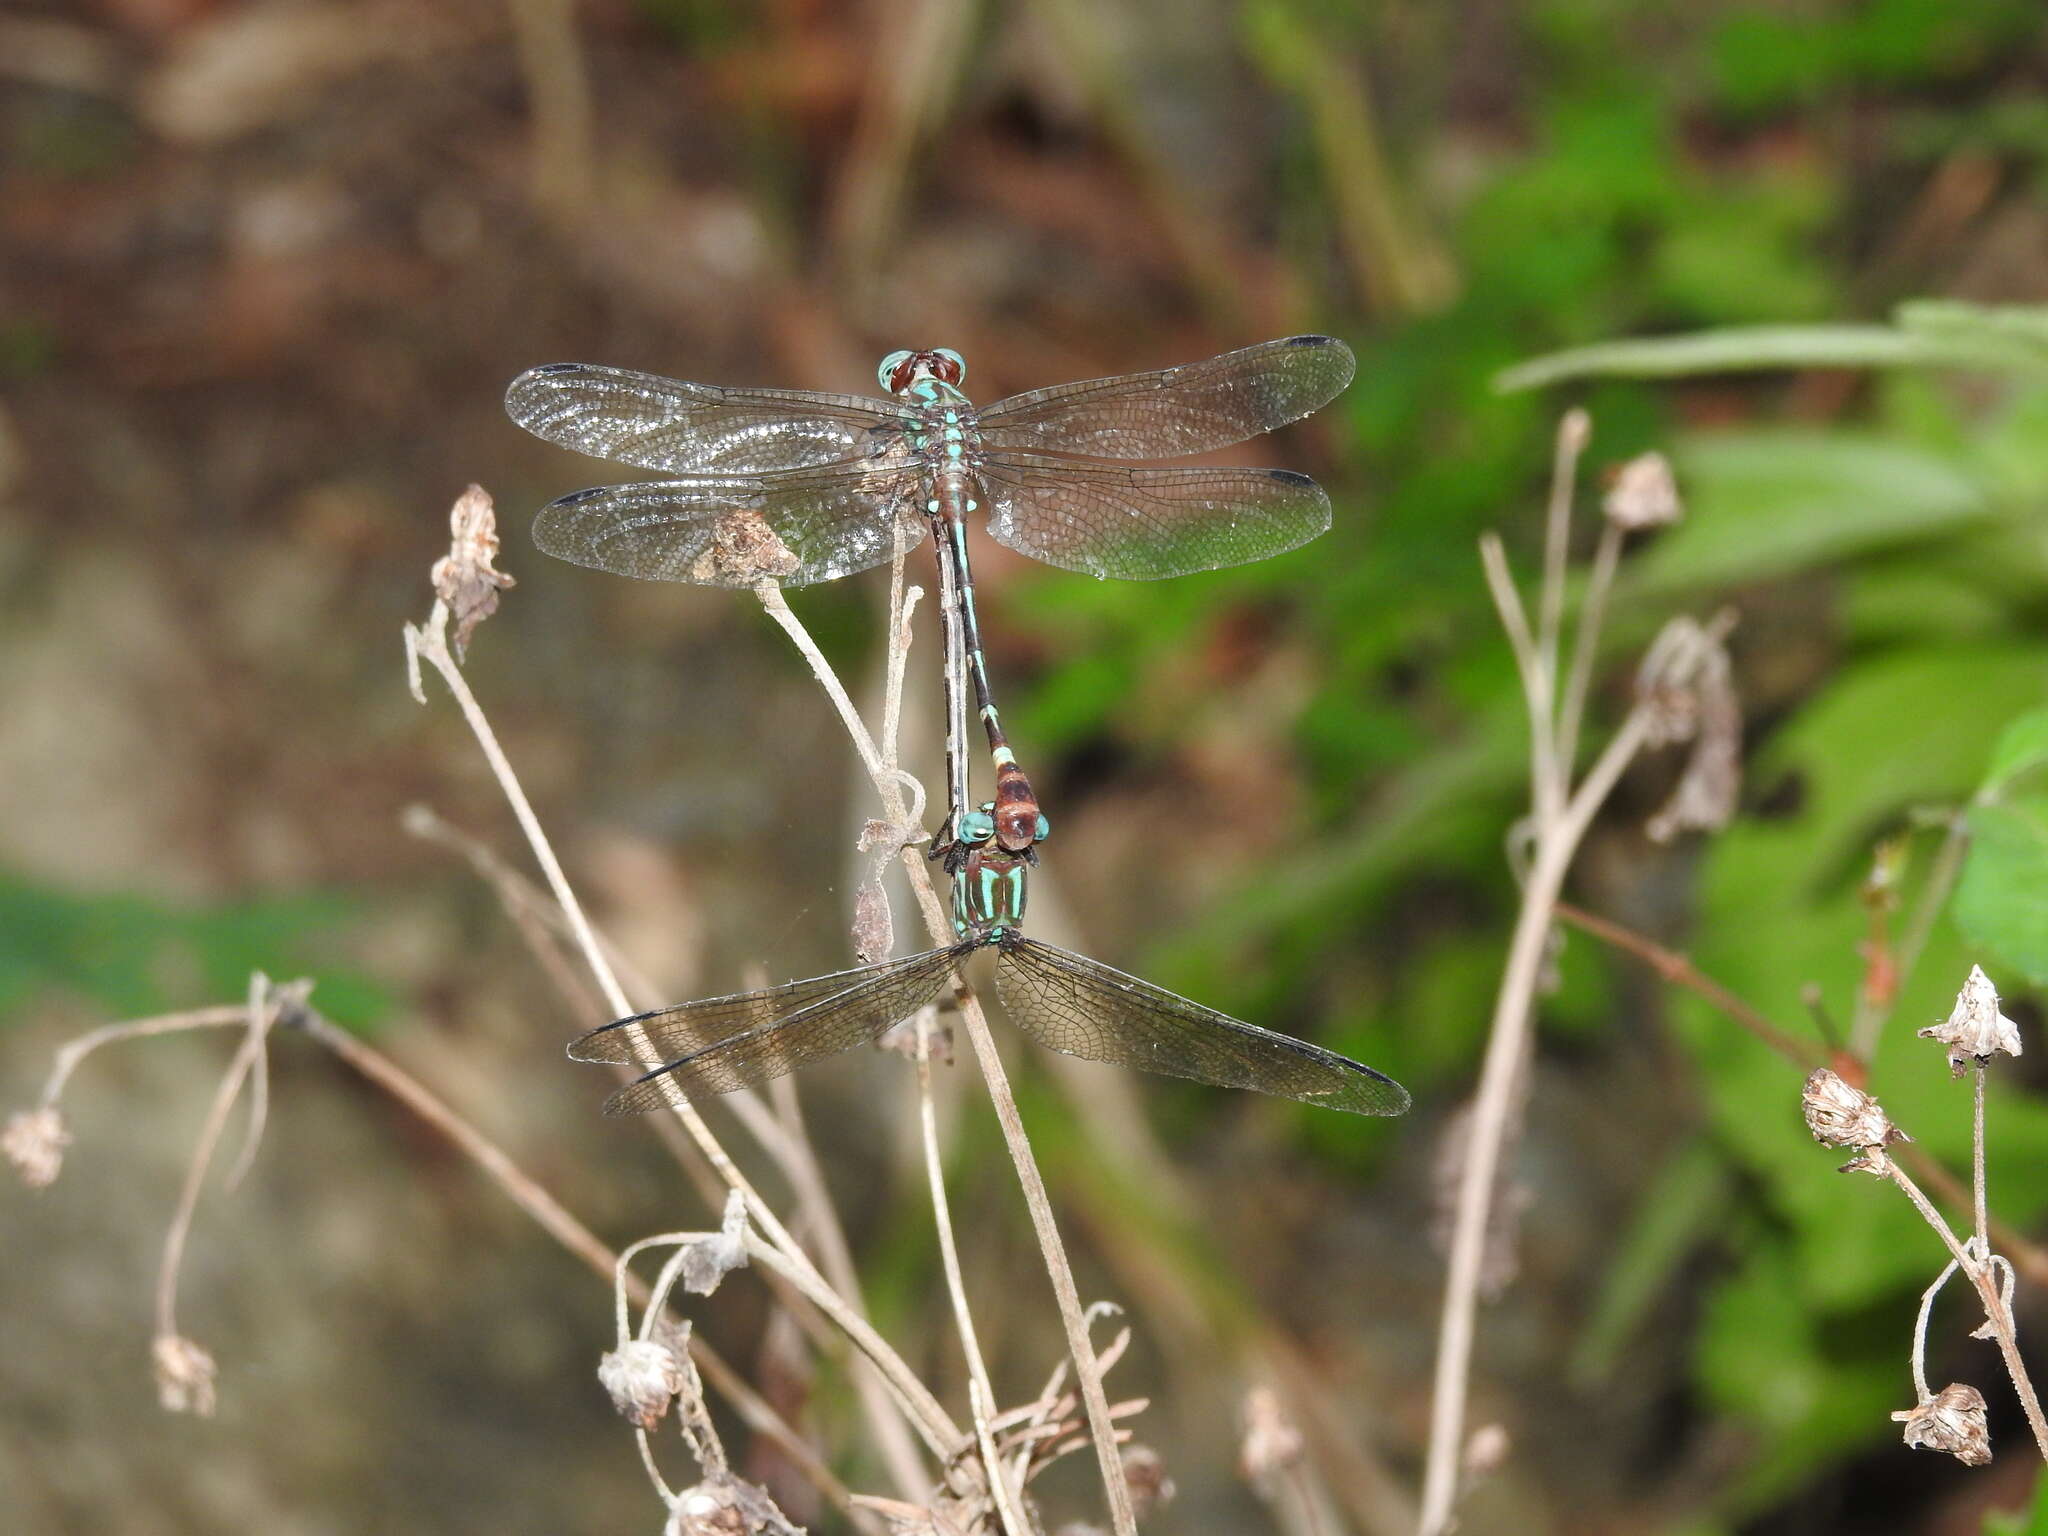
<box><xmin>506</xmin><ymin>336</ymin><xmax>1354</xmax><ymax>870</ymax></box>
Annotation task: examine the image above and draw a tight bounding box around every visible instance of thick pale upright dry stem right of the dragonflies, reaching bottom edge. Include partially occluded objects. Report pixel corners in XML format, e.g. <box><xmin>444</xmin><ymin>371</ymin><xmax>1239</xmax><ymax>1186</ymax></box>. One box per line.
<box><xmin>1419</xmin><ymin>712</ymin><xmax>1649</xmax><ymax>1536</ymax></box>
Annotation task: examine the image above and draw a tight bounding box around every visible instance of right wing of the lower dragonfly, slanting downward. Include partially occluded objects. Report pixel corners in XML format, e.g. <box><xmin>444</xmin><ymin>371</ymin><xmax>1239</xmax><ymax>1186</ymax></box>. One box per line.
<box><xmin>995</xmin><ymin>938</ymin><xmax>1409</xmax><ymax>1114</ymax></box>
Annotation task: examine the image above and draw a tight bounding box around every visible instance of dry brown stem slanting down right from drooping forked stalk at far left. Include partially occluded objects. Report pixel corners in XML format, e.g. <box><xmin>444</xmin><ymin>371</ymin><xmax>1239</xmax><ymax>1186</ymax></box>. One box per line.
<box><xmin>284</xmin><ymin>1010</ymin><xmax>852</xmax><ymax>1511</ymax></box>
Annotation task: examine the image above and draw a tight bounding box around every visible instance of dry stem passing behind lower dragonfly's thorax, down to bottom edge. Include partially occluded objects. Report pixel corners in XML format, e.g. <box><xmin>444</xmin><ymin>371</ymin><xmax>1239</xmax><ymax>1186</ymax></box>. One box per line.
<box><xmin>756</xmin><ymin>584</ymin><xmax>1137</xmax><ymax>1536</ymax></box>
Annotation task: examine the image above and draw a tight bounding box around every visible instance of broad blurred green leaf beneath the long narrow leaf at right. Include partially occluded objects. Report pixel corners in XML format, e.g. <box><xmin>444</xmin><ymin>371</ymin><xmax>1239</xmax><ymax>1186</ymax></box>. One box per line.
<box><xmin>1634</xmin><ymin>430</ymin><xmax>1991</xmax><ymax>592</ymax></box>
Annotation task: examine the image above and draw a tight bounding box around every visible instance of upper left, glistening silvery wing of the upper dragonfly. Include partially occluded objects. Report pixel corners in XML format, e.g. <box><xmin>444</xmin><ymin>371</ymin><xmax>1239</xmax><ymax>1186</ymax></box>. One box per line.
<box><xmin>506</xmin><ymin>362</ymin><xmax>909</xmax><ymax>475</ymax></box>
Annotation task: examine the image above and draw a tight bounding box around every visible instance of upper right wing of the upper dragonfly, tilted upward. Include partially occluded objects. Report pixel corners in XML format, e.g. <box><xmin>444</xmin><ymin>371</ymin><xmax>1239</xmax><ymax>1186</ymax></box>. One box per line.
<box><xmin>975</xmin><ymin>336</ymin><xmax>1358</xmax><ymax>459</ymax></box>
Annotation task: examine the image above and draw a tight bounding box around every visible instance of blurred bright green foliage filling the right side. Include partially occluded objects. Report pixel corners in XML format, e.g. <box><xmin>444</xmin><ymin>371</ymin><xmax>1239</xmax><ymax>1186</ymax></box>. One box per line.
<box><xmin>1014</xmin><ymin>0</ymin><xmax>2048</xmax><ymax>1520</ymax></box>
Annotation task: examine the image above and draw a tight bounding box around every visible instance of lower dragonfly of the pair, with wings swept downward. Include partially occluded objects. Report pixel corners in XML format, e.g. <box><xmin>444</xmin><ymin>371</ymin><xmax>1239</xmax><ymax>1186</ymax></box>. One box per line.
<box><xmin>569</xmin><ymin>842</ymin><xmax>1409</xmax><ymax>1114</ymax></box>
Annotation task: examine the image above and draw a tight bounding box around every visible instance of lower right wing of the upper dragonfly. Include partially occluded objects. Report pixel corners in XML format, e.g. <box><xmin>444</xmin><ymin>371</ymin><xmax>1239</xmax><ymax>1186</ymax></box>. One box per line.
<box><xmin>979</xmin><ymin>455</ymin><xmax>1329</xmax><ymax>582</ymax></box>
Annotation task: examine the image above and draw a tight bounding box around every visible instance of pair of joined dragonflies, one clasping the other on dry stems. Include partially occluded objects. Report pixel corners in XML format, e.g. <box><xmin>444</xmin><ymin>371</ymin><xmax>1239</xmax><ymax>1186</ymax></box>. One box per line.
<box><xmin>506</xmin><ymin>336</ymin><xmax>1409</xmax><ymax>1114</ymax></box>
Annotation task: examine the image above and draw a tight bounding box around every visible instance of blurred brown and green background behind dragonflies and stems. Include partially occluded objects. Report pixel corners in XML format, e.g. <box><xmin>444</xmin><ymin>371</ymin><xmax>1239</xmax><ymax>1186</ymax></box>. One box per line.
<box><xmin>12</xmin><ymin>0</ymin><xmax>2048</xmax><ymax>1534</ymax></box>
